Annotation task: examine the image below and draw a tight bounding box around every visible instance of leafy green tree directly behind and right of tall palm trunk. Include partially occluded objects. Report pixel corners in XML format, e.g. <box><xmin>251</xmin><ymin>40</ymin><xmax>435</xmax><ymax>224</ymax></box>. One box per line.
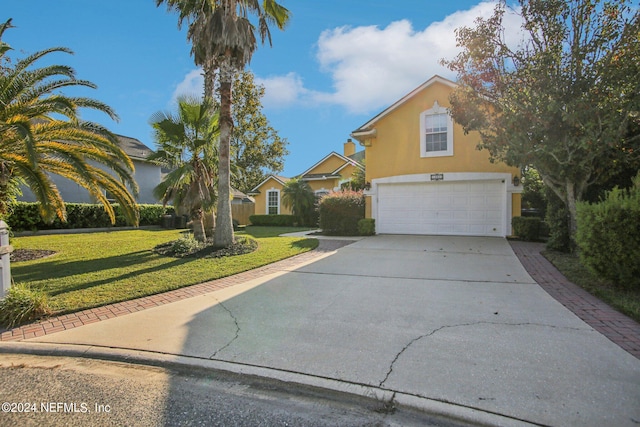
<box><xmin>231</xmin><ymin>71</ymin><xmax>289</xmax><ymax>193</ymax></box>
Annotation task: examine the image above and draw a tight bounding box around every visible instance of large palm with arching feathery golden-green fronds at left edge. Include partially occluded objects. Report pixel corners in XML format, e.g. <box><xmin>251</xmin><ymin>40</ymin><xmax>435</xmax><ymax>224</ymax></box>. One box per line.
<box><xmin>0</xmin><ymin>19</ymin><xmax>138</xmax><ymax>225</ymax></box>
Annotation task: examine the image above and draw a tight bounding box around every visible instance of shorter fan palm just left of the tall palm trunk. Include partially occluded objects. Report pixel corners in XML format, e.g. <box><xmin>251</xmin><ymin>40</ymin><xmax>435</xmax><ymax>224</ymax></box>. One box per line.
<box><xmin>149</xmin><ymin>97</ymin><xmax>219</xmax><ymax>242</ymax></box>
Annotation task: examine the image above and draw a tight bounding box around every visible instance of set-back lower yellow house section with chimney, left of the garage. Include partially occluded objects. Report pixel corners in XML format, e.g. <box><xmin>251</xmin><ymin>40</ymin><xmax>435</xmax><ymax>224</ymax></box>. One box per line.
<box><xmin>249</xmin><ymin>140</ymin><xmax>364</xmax><ymax>215</ymax></box>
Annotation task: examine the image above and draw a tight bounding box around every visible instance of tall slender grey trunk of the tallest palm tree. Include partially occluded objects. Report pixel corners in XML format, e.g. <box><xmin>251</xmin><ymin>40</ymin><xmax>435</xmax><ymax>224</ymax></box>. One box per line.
<box><xmin>214</xmin><ymin>58</ymin><xmax>234</xmax><ymax>248</ymax></box>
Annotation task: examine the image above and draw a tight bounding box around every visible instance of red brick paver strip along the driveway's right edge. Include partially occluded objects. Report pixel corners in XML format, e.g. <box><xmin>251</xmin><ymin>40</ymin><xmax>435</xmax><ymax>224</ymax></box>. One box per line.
<box><xmin>509</xmin><ymin>240</ymin><xmax>640</xmax><ymax>359</ymax></box>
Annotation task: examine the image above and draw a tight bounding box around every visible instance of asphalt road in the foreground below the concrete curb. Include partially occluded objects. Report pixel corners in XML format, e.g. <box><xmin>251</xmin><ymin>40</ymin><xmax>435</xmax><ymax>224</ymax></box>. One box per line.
<box><xmin>0</xmin><ymin>354</ymin><xmax>470</xmax><ymax>427</ymax></box>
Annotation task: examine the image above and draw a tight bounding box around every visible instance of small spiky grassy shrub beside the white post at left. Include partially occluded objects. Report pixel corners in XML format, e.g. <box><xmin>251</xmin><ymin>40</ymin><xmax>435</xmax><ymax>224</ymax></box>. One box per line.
<box><xmin>0</xmin><ymin>285</ymin><xmax>51</xmax><ymax>328</ymax></box>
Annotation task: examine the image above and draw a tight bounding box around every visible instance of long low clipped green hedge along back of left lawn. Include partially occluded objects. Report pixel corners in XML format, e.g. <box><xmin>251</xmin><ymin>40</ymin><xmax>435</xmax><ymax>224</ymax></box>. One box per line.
<box><xmin>5</xmin><ymin>202</ymin><xmax>173</xmax><ymax>232</ymax></box>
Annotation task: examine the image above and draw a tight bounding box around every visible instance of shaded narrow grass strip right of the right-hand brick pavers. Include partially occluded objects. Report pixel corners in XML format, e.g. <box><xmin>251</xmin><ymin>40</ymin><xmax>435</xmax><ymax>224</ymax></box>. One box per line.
<box><xmin>543</xmin><ymin>251</ymin><xmax>640</xmax><ymax>322</ymax></box>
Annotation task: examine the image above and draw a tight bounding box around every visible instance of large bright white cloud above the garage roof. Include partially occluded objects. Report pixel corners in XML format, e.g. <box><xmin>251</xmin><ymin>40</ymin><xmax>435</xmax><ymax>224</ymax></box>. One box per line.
<box><xmin>317</xmin><ymin>2</ymin><xmax>518</xmax><ymax>113</ymax></box>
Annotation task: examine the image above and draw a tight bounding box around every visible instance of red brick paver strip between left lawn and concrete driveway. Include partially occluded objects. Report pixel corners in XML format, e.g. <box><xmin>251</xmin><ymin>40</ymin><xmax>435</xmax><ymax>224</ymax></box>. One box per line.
<box><xmin>0</xmin><ymin>239</ymin><xmax>353</xmax><ymax>341</ymax></box>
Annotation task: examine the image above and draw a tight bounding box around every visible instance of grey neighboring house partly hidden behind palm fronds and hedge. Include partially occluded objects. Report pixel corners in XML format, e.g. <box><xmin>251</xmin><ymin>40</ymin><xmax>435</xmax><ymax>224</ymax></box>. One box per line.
<box><xmin>19</xmin><ymin>135</ymin><xmax>162</xmax><ymax>204</ymax></box>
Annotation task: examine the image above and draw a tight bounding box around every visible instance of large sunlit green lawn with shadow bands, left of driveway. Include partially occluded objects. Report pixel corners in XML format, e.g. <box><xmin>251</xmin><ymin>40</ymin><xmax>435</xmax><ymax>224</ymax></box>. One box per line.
<box><xmin>11</xmin><ymin>227</ymin><xmax>318</xmax><ymax>313</ymax></box>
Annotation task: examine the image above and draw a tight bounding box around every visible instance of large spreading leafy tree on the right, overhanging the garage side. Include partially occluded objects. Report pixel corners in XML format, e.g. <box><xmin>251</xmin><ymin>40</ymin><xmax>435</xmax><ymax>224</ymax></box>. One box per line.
<box><xmin>443</xmin><ymin>0</ymin><xmax>640</xmax><ymax>241</ymax></box>
